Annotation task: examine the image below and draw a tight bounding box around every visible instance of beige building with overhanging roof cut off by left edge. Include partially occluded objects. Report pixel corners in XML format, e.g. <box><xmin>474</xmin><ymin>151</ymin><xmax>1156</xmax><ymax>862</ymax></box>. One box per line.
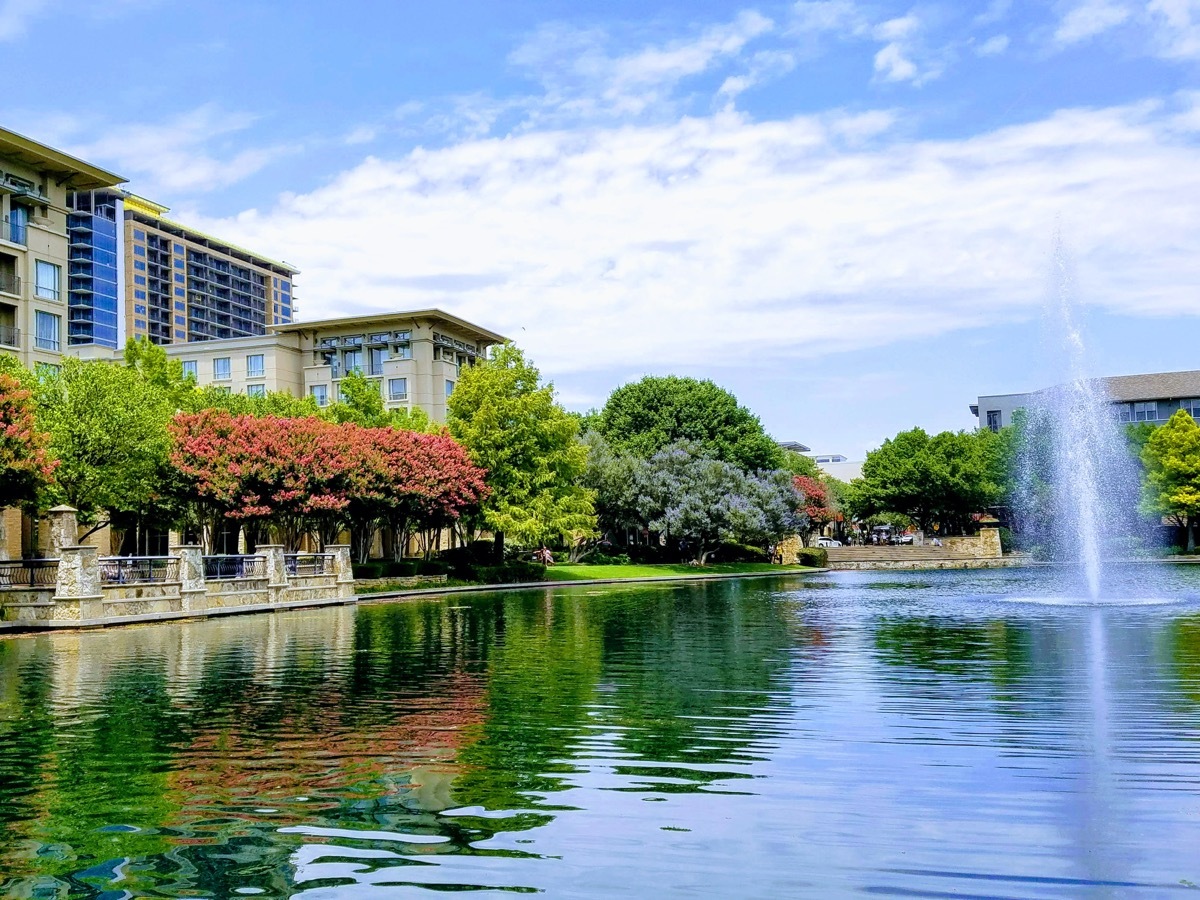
<box><xmin>0</xmin><ymin>128</ymin><xmax>125</xmax><ymax>368</ymax></box>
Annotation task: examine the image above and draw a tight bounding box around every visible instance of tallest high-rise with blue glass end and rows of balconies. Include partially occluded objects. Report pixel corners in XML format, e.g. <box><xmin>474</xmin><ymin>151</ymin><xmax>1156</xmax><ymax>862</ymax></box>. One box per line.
<box><xmin>68</xmin><ymin>191</ymin><xmax>298</xmax><ymax>348</ymax></box>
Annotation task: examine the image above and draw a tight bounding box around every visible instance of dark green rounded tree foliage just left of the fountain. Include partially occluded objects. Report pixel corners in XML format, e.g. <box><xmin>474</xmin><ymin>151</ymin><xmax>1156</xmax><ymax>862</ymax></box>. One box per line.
<box><xmin>851</xmin><ymin>428</ymin><xmax>1008</xmax><ymax>533</ymax></box>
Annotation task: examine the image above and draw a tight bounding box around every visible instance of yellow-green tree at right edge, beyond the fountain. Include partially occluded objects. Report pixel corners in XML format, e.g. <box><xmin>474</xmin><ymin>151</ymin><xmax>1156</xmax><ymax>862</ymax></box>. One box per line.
<box><xmin>1141</xmin><ymin>409</ymin><xmax>1200</xmax><ymax>553</ymax></box>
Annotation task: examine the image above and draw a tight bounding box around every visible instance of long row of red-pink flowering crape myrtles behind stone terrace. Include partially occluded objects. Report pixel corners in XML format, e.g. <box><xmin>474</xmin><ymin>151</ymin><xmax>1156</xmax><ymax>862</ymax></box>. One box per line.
<box><xmin>170</xmin><ymin>409</ymin><xmax>487</xmax><ymax>562</ymax></box>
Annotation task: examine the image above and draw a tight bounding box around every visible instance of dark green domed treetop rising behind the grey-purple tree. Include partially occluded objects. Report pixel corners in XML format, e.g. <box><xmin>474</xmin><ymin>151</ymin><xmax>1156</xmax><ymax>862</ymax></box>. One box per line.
<box><xmin>599</xmin><ymin>376</ymin><xmax>782</xmax><ymax>474</ymax></box>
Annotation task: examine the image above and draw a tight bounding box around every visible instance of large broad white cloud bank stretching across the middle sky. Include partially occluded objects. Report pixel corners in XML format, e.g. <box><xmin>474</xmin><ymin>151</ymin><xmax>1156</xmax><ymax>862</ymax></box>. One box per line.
<box><xmin>197</xmin><ymin>104</ymin><xmax>1200</xmax><ymax>378</ymax></box>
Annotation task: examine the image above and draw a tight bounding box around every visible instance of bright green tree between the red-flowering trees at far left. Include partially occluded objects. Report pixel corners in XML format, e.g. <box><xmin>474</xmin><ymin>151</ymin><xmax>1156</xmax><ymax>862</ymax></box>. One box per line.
<box><xmin>37</xmin><ymin>358</ymin><xmax>175</xmax><ymax>540</ymax></box>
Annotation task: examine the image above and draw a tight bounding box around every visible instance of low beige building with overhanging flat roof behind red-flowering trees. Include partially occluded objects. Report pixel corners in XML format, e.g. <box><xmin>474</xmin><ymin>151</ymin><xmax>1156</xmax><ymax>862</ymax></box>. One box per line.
<box><xmin>166</xmin><ymin>310</ymin><xmax>506</xmax><ymax>422</ymax></box>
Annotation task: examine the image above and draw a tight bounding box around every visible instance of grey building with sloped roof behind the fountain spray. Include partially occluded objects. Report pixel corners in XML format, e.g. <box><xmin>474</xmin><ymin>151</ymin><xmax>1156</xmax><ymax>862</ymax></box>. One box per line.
<box><xmin>971</xmin><ymin>371</ymin><xmax>1200</xmax><ymax>431</ymax></box>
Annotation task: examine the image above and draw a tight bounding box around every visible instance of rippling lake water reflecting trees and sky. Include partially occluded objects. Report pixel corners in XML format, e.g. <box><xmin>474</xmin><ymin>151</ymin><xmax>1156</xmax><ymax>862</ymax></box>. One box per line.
<box><xmin>7</xmin><ymin>566</ymin><xmax>1200</xmax><ymax>900</ymax></box>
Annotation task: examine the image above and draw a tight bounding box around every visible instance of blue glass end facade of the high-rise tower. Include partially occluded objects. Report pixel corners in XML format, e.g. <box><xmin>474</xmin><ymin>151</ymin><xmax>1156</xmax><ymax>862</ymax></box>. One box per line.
<box><xmin>67</xmin><ymin>191</ymin><xmax>119</xmax><ymax>348</ymax></box>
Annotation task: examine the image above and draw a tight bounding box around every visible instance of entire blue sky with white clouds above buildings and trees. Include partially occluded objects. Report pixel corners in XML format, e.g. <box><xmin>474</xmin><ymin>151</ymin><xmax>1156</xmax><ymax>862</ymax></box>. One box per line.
<box><xmin>0</xmin><ymin>0</ymin><xmax>1200</xmax><ymax>457</ymax></box>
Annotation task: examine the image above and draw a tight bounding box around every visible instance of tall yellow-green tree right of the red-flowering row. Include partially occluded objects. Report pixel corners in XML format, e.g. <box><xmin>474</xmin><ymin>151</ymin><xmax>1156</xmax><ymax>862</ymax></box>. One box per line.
<box><xmin>448</xmin><ymin>344</ymin><xmax>595</xmax><ymax>547</ymax></box>
